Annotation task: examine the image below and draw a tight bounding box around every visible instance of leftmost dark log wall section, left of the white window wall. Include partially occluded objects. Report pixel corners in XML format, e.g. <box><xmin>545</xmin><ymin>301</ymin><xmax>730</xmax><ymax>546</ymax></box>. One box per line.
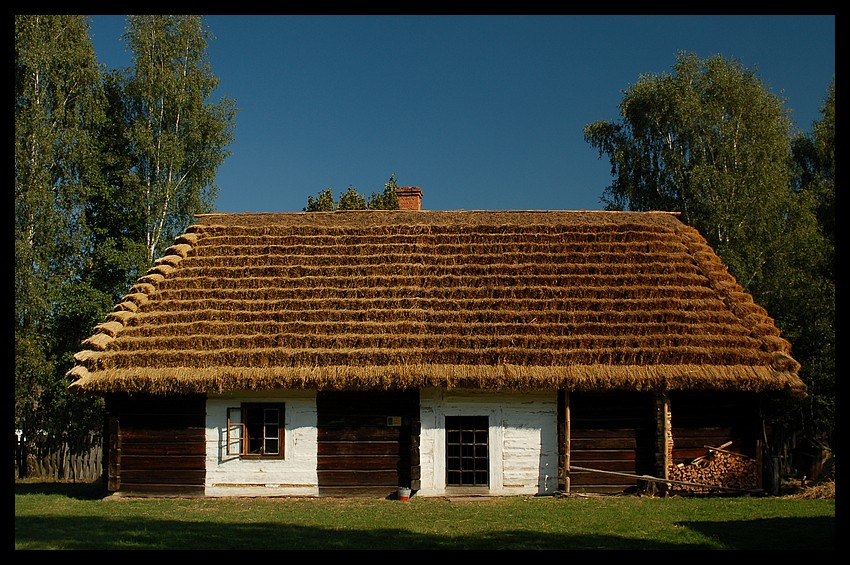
<box><xmin>106</xmin><ymin>395</ymin><xmax>206</xmax><ymax>496</ymax></box>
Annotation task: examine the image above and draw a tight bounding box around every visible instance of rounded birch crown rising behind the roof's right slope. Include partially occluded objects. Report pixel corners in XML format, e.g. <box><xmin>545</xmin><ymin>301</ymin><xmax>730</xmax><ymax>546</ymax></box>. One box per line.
<box><xmin>585</xmin><ymin>53</ymin><xmax>794</xmax><ymax>287</ymax></box>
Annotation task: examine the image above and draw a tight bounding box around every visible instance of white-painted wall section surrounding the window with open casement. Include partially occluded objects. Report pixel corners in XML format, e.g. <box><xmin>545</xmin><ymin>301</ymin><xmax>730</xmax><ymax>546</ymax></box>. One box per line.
<box><xmin>204</xmin><ymin>390</ymin><xmax>319</xmax><ymax>496</ymax></box>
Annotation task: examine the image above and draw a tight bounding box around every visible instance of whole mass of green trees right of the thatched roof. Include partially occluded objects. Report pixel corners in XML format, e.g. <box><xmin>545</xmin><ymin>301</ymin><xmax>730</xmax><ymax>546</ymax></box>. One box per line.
<box><xmin>584</xmin><ymin>53</ymin><xmax>835</xmax><ymax>437</ymax></box>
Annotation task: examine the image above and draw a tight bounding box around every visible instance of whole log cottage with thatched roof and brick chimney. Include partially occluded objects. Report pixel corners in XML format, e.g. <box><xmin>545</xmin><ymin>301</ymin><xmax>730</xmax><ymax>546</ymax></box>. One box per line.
<box><xmin>64</xmin><ymin>190</ymin><xmax>805</xmax><ymax>497</ymax></box>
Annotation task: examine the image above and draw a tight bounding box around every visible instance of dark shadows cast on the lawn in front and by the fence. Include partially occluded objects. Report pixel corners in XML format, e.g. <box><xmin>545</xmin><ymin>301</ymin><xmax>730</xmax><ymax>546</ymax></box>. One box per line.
<box><xmin>15</xmin><ymin>482</ymin><xmax>835</xmax><ymax>550</ymax></box>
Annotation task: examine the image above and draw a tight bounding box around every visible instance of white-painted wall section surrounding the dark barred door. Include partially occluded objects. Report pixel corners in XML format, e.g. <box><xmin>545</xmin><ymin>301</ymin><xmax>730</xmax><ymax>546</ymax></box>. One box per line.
<box><xmin>417</xmin><ymin>388</ymin><xmax>558</xmax><ymax>496</ymax></box>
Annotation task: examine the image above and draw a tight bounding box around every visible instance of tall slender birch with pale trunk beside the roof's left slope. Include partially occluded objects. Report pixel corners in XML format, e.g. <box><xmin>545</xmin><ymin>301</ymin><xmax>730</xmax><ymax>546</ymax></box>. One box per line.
<box><xmin>125</xmin><ymin>15</ymin><xmax>236</xmax><ymax>262</ymax></box>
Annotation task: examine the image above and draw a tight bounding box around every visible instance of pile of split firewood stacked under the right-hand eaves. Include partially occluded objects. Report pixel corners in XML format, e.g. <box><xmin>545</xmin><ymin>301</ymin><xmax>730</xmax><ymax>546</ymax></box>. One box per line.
<box><xmin>667</xmin><ymin>442</ymin><xmax>759</xmax><ymax>494</ymax></box>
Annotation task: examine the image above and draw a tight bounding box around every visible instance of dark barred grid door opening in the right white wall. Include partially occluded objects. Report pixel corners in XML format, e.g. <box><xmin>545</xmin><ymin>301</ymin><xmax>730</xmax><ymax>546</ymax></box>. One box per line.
<box><xmin>446</xmin><ymin>416</ymin><xmax>490</xmax><ymax>487</ymax></box>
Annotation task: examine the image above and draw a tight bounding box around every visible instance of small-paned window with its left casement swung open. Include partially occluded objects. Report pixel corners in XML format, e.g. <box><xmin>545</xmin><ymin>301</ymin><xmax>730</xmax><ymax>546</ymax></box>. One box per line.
<box><xmin>226</xmin><ymin>402</ymin><xmax>285</xmax><ymax>459</ymax></box>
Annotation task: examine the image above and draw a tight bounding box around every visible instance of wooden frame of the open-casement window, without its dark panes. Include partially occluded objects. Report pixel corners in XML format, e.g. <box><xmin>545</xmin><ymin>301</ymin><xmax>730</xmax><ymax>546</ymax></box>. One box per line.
<box><xmin>225</xmin><ymin>402</ymin><xmax>286</xmax><ymax>459</ymax></box>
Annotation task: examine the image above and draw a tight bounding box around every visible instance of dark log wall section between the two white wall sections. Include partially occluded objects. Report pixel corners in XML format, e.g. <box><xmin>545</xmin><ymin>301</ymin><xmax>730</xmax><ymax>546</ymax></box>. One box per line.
<box><xmin>316</xmin><ymin>391</ymin><xmax>420</xmax><ymax>496</ymax></box>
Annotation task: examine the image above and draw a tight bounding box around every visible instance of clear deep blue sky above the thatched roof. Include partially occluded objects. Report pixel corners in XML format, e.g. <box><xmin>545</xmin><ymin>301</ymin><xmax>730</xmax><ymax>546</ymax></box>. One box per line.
<box><xmin>91</xmin><ymin>15</ymin><xmax>835</xmax><ymax>212</ymax></box>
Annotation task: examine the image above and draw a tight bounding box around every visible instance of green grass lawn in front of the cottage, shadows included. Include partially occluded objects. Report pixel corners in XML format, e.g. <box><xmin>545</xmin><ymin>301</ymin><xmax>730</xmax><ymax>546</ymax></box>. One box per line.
<box><xmin>15</xmin><ymin>483</ymin><xmax>835</xmax><ymax>550</ymax></box>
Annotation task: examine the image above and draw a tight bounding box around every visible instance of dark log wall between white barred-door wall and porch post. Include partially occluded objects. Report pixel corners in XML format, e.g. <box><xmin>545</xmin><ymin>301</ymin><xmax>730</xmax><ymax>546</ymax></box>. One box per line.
<box><xmin>568</xmin><ymin>392</ymin><xmax>656</xmax><ymax>493</ymax></box>
